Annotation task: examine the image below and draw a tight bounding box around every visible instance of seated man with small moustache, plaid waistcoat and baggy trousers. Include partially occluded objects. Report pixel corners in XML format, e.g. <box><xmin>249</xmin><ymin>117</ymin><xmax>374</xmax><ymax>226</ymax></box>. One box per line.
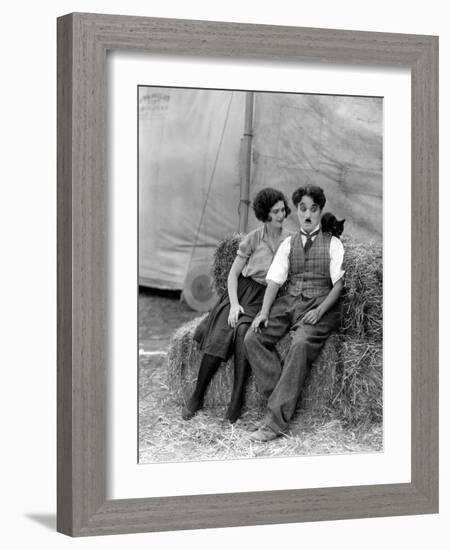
<box><xmin>244</xmin><ymin>185</ymin><xmax>344</xmax><ymax>442</ymax></box>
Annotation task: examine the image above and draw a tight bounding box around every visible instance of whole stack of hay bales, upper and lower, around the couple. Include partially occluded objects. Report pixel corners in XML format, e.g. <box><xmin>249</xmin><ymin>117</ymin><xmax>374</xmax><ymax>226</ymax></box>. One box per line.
<box><xmin>168</xmin><ymin>234</ymin><xmax>383</xmax><ymax>427</ymax></box>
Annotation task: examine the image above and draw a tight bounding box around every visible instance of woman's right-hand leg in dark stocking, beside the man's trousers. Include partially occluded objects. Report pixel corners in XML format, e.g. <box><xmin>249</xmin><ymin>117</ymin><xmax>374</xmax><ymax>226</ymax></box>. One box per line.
<box><xmin>225</xmin><ymin>324</ymin><xmax>250</xmax><ymax>424</ymax></box>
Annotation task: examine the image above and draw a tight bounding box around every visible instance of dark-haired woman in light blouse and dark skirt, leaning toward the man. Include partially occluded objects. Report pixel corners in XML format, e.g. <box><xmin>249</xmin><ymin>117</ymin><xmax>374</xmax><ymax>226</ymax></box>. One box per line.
<box><xmin>181</xmin><ymin>187</ymin><xmax>291</xmax><ymax>423</ymax></box>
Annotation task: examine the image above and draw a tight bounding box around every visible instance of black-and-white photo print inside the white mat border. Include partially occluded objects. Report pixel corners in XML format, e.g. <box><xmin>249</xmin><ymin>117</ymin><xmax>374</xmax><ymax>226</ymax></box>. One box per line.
<box><xmin>138</xmin><ymin>85</ymin><xmax>383</xmax><ymax>464</ymax></box>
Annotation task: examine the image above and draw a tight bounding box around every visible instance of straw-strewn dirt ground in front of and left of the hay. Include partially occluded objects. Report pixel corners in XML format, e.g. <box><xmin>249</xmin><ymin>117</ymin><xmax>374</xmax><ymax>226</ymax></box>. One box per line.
<box><xmin>139</xmin><ymin>289</ymin><xmax>382</xmax><ymax>463</ymax></box>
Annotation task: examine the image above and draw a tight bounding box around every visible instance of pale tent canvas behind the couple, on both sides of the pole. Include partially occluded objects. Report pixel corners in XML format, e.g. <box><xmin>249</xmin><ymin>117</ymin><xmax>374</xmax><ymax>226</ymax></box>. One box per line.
<box><xmin>139</xmin><ymin>86</ymin><xmax>383</xmax><ymax>298</ymax></box>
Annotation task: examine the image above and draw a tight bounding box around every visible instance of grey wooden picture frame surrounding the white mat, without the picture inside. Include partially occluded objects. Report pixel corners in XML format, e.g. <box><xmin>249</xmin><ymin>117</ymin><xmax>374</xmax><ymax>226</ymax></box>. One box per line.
<box><xmin>57</xmin><ymin>13</ymin><xmax>438</xmax><ymax>536</ymax></box>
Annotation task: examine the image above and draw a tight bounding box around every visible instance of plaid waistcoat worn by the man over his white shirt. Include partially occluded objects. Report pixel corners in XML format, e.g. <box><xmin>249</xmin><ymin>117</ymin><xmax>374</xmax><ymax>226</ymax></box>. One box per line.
<box><xmin>287</xmin><ymin>231</ymin><xmax>333</xmax><ymax>298</ymax></box>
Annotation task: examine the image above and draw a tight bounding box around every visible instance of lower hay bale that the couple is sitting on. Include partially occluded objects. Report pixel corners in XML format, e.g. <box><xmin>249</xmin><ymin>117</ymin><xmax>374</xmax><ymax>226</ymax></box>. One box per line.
<box><xmin>167</xmin><ymin>317</ymin><xmax>383</xmax><ymax>427</ymax></box>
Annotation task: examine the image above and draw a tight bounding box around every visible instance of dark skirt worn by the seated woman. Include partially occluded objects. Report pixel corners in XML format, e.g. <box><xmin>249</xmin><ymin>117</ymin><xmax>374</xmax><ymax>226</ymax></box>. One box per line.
<box><xmin>194</xmin><ymin>275</ymin><xmax>266</xmax><ymax>361</ymax></box>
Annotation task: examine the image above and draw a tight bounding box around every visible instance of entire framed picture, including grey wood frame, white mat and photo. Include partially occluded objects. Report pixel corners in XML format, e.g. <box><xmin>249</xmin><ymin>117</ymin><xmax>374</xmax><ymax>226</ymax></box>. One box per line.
<box><xmin>58</xmin><ymin>14</ymin><xmax>438</xmax><ymax>536</ymax></box>
